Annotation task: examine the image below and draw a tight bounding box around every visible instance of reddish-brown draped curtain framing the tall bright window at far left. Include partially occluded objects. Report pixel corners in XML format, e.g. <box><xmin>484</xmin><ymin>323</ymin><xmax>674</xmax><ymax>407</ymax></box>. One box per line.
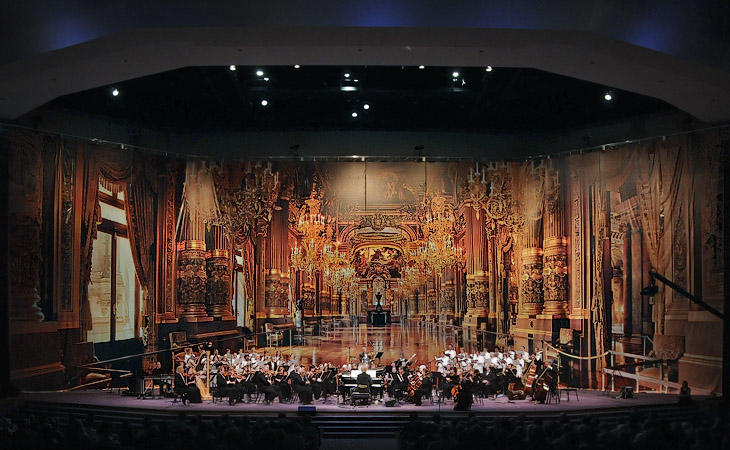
<box><xmin>79</xmin><ymin>144</ymin><xmax>157</xmax><ymax>331</ymax></box>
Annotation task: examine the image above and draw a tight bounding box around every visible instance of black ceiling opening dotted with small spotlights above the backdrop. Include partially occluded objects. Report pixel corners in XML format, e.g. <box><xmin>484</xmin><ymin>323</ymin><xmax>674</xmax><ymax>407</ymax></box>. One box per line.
<box><xmin>48</xmin><ymin>66</ymin><xmax>678</xmax><ymax>132</ymax></box>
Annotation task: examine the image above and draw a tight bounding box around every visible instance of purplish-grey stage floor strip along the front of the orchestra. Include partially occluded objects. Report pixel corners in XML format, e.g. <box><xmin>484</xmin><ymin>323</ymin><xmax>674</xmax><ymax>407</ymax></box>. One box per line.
<box><xmin>7</xmin><ymin>390</ymin><xmax>688</xmax><ymax>416</ymax></box>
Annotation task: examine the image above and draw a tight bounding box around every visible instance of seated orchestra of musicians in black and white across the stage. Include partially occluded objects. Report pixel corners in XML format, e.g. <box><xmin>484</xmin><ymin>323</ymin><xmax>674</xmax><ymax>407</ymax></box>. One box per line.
<box><xmin>158</xmin><ymin>345</ymin><xmax>557</xmax><ymax>410</ymax></box>
